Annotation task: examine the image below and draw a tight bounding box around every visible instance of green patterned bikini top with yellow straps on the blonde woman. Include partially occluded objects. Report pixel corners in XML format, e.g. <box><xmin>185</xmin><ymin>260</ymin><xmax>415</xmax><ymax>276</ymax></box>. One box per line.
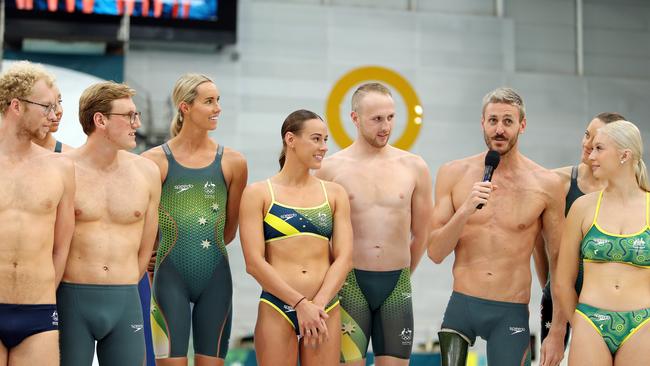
<box><xmin>580</xmin><ymin>191</ymin><xmax>650</xmax><ymax>267</ymax></box>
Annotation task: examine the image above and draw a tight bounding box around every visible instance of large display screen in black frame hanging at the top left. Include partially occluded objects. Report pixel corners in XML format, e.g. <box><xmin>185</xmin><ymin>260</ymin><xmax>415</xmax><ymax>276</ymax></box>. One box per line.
<box><xmin>4</xmin><ymin>0</ymin><xmax>237</xmax><ymax>45</ymax></box>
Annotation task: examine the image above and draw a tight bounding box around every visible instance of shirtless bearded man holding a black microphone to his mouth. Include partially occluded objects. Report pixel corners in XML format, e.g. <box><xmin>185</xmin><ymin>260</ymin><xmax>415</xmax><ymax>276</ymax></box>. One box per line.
<box><xmin>428</xmin><ymin>88</ymin><xmax>566</xmax><ymax>366</ymax></box>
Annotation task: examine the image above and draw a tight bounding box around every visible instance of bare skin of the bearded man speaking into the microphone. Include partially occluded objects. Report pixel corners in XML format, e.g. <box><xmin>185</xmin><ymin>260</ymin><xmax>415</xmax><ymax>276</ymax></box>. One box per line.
<box><xmin>428</xmin><ymin>103</ymin><xmax>565</xmax><ymax>365</ymax></box>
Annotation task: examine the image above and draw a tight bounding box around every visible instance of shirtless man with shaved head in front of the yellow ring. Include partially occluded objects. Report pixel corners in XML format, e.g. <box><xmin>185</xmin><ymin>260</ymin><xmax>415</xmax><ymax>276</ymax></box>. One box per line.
<box><xmin>316</xmin><ymin>83</ymin><xmax>431</xmax><ymax>366</ymax></box>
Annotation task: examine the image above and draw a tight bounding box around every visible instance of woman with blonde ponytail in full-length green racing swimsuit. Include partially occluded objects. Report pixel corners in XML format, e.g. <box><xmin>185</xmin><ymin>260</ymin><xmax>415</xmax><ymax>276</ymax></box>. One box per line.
<box><xmin>143</xmin><ymin>74</ymin><xmax>247</xmax><ymax>366</ymax></box>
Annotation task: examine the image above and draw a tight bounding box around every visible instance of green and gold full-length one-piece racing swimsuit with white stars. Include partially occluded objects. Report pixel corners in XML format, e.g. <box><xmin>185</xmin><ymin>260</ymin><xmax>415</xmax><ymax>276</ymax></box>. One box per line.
<box><xmin>151</xmin><ymin>144</ymin><xmax>232</xmax><ymax>358</ymax></box>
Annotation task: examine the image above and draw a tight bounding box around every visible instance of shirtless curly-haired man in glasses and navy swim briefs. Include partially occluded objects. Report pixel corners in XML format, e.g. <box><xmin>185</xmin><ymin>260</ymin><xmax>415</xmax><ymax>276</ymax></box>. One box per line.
<box><xmin>0</xmin><ymin>62</ymin><xmax>75</xmax><ymax>366</ymax></box>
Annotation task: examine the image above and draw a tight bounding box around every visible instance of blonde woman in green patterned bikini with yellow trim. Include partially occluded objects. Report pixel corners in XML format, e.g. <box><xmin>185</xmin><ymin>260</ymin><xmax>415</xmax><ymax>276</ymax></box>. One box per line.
<box><xmin>553</xmin><ymin>121</ymin><xmax>650</xmax><ymax>366</ymax></box>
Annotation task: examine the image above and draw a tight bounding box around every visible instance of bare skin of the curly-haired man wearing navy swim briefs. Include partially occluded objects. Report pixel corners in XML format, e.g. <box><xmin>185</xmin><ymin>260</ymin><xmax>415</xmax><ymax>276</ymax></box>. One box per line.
<box><xmin>0</xmin><ymin>80</ymin><xmax>75</xmax><ymax>366</ymax></box>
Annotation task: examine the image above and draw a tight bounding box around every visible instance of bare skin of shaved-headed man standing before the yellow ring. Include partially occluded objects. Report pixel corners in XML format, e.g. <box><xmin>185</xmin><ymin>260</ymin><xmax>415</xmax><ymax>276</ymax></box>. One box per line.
<box><xmin>316</xmin><ymin>92</ymin><xmax>431</xmax><ymax>366</ymax></box>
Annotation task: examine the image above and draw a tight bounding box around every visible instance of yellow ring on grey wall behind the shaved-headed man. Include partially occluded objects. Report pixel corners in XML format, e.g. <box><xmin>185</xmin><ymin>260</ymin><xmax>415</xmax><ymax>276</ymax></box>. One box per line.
<box><xmin>325</xmin><ymin>66</ymin><xmax>422</xmax><ymax>150</ymax></box>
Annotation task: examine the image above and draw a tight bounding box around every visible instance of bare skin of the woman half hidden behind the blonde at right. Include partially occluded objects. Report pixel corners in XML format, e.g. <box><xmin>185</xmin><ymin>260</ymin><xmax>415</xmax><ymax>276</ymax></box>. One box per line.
<box><xmin>533</xmin><ymin>118</ymin><xmax>606</xmax><ymax>287</ymax></box>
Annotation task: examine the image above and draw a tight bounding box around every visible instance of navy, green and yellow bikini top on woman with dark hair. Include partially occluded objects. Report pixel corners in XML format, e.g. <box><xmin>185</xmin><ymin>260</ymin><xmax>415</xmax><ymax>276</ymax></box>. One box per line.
<box><xmin>264</xmin><ymin>179</ymin><xmax>333</xmax><ymax>243</ymax></box>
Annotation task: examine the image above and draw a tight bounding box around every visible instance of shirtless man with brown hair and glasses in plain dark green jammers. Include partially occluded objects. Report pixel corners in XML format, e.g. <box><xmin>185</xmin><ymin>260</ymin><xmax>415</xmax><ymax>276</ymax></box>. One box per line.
<box><xmin>57</xmin><ymin>82</ymin><xmax>160</xmax><ymax>366</ymax></box>
